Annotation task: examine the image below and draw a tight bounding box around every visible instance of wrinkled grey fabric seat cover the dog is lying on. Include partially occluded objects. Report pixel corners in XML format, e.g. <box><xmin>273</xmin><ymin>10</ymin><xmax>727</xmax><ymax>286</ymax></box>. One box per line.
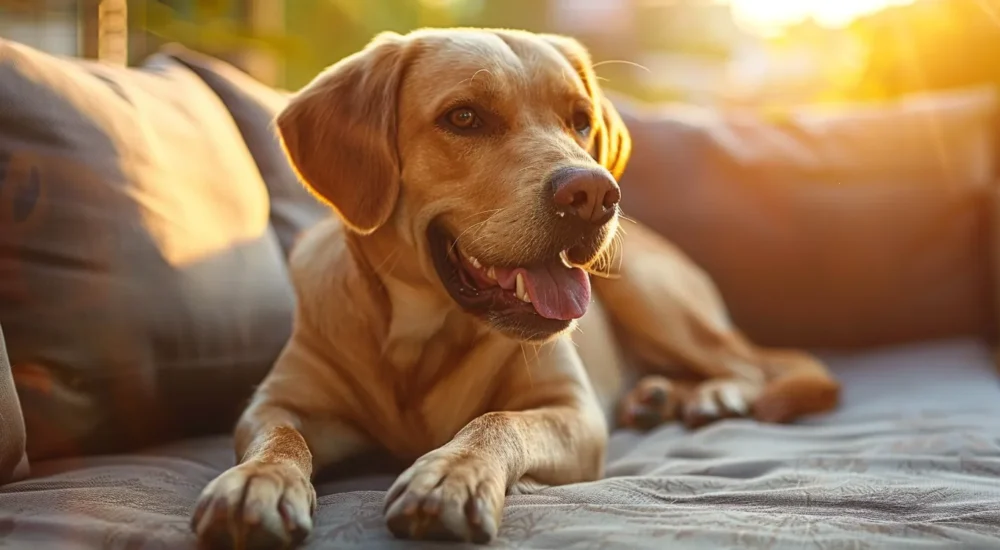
<box><xmin>0</xmin><ymin>341</ymin><xmax>1000</xmax><ymax>550</ymax></box>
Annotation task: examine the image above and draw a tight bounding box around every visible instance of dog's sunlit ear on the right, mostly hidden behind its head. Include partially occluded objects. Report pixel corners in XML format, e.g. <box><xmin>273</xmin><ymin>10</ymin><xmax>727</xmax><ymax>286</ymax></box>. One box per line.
<box><xmin>542</xmin><ymin>34</ymin><xmax>632</xmax><ymax>179</ymax></box>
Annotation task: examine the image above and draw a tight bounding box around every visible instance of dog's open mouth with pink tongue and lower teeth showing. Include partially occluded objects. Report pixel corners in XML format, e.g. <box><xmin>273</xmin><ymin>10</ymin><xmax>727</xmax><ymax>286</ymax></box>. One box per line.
<box><xmin>428</xmin><ymin>225</ymin><xmax>590</xmax><ymax>333</ymax></box>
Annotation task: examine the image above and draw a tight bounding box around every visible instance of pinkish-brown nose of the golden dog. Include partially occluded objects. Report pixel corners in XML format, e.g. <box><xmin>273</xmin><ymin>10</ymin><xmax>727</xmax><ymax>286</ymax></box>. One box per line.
<box><xmin>549</xmin><ymin>168</ymin><xmax>622</xmax><ymax>225</ymax></box>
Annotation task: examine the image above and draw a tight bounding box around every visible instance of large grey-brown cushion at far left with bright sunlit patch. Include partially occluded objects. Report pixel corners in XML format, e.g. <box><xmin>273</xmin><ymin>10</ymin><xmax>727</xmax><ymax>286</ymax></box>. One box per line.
<box><xmin>0</xmin><ymin>41</ymin><xmax>293</xmax><ymax>460</ymax></box>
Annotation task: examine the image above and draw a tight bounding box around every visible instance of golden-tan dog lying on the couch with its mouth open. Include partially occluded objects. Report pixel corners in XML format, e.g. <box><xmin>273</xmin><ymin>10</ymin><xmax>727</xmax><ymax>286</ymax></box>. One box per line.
<box><xmin>192</xmin><ymin>29</ymin><xmax>839</xmax><ymax>548</ymax></box>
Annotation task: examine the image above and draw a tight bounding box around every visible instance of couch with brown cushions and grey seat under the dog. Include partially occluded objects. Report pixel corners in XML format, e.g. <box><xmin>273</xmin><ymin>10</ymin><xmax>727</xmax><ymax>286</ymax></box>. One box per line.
<box><xmin>0</xmin><ymin>40</ymin><xmax>1000</xmax><ymax>550</ymax></box>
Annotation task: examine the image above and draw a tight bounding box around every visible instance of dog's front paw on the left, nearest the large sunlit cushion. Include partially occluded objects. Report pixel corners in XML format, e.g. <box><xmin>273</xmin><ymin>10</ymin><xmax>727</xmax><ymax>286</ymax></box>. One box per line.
<box><xmin>191</xmin><ymin>462</ymin><xmax>316</xmax><ymax>549</ymax></box>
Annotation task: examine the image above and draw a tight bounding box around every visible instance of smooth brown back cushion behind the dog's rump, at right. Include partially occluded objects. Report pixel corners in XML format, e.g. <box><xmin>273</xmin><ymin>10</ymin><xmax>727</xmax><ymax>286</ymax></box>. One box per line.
<box><xmin>620</xmin><ymin>91</ymin><xmax>996</xmax><ymax>347</ymax></box>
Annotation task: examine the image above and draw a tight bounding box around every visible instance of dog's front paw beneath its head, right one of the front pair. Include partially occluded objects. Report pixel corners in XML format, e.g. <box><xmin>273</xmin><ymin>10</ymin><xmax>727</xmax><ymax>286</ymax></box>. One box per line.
<box><xmin>385</xmin><ymin>451</ymin><xmax>506</xmax><ymax>544</ymax></box>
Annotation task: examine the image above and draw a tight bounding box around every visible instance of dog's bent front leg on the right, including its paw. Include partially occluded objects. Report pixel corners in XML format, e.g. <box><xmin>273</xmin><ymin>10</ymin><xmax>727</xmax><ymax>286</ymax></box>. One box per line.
<box><xmin>385</xmin><ymin>339</ymin><xmax>607</xmax><ymax>543</ymax></box>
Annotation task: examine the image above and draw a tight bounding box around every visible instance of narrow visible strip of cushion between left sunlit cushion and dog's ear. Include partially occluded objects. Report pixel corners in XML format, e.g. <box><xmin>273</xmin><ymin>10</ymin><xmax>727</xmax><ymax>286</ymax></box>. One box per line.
<box><xmin>162</xmin><ymin>44</ymin><xmax>330</xmax><ymax>256</ymax></box>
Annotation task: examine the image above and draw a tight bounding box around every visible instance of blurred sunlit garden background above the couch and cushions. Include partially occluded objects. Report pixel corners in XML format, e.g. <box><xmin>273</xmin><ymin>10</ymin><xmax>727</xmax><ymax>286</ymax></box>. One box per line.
<box><xmin>0</xmin><ymin>0</ymin><xmax>1000</xmax><ymax>109</ymax></box>
